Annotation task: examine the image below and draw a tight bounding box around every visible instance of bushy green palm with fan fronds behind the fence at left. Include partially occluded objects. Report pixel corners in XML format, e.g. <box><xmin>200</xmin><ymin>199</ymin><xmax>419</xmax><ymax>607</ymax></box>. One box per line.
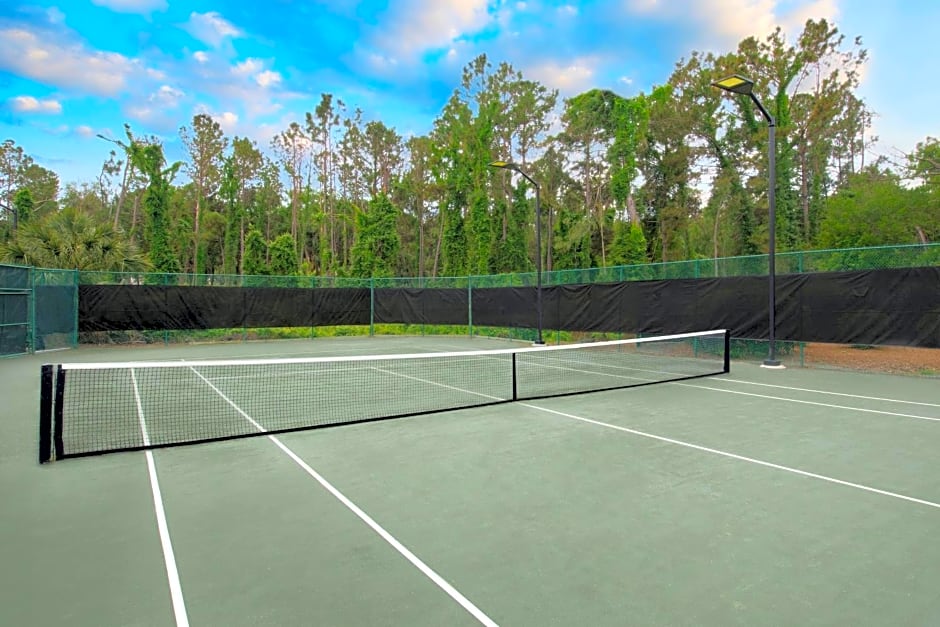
<box><xmin>0</xmin><ymin>207</ymin><xmax>150</xmax><ymax>272</ymax></box>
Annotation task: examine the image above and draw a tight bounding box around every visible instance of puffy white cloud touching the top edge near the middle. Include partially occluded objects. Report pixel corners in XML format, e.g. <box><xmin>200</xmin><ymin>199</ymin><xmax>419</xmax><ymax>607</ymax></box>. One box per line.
<box><xmin>373</xmin><ymin>0</ymin><xmax>491</xmax><ymax>58</ymax></box>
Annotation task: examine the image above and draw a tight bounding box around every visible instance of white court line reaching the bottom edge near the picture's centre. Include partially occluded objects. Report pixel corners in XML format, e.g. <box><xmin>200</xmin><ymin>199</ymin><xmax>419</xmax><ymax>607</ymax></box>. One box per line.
<box><xmin>190</xmin><ymin>366</ymin><xmax>498</xmax><ymax>627</ymax></box>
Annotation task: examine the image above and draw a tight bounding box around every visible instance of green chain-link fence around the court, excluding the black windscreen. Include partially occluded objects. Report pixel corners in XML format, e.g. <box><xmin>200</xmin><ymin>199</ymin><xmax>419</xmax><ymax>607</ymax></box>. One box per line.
<box><xmin>14</xmin><ymin>243</ymin><xmax>940</xmax><ymax>354</ymax></box>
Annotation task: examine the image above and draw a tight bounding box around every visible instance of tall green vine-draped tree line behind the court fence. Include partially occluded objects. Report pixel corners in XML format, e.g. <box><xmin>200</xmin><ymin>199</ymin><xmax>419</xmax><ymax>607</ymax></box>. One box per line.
<box><xmin>0</xmin><ymin>20</ymin><xmax>940</xmax><ymax>277</ymax></box>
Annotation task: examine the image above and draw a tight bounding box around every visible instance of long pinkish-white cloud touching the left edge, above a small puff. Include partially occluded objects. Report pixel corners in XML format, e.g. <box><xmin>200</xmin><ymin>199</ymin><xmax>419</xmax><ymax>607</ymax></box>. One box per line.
<box><xmin>0</xmin><ymin>28</ymin><xmax>137</xmax><ymax>96</ymax></box>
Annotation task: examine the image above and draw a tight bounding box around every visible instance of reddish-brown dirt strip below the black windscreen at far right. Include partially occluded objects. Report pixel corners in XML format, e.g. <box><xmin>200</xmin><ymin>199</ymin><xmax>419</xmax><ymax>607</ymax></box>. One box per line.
<box><xmin>804</xmin><ymin>344</ymin><xmax>940</xmax><ymax>377</ymax></box>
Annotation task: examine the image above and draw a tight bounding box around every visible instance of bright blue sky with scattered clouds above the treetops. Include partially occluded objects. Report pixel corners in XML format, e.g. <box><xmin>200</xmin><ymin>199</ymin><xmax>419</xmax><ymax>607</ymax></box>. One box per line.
<box><xmin>0</xmin><ymin>0</ymin><xmax>940</xmax><ymax>183</ymax></box>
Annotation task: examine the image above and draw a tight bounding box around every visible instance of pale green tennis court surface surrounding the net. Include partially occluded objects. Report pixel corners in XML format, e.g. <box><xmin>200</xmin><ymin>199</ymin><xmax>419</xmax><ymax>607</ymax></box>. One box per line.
<box><xmin>0</xmin><ymin>338</ymin><xmax>940</xmax><ymax>625</ymax></box>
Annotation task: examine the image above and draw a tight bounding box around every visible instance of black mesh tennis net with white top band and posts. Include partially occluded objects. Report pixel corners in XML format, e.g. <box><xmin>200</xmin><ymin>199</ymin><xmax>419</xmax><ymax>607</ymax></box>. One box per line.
<box><xmin>39</xmin><ymin>331</ymin><xmax>729</xmax><ymax>462</ymax></box>
